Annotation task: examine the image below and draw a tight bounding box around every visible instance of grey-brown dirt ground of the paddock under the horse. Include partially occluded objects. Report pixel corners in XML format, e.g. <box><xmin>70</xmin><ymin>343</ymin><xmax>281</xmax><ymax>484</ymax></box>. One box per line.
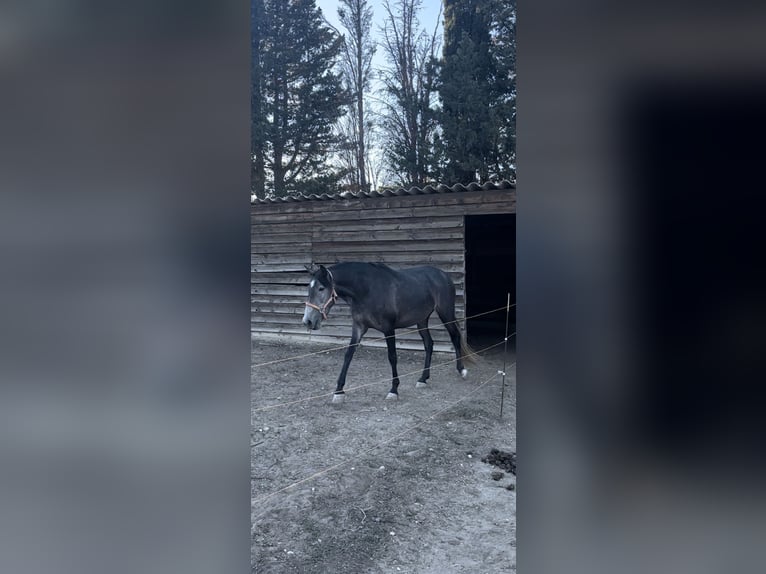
<box><xmin>251</xmin><ymin>342</ymin><xmax>516</xmax><ymax>574</ymax></box>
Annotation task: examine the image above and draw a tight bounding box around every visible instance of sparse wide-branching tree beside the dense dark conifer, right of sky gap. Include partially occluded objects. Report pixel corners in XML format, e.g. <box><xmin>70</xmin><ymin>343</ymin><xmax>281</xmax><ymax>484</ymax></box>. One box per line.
<box><xmin>382</xmin><ymin>0</ymin><xmax>437</xmax><ymax>185</ymax></box>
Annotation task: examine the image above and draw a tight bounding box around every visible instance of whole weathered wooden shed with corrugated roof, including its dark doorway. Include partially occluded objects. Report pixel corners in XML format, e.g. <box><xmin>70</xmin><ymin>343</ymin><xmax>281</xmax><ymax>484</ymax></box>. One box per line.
<box><xmin>250</xmin><ymin>181</ymin><xmax>516</xmax><ymax>351</ymax></box>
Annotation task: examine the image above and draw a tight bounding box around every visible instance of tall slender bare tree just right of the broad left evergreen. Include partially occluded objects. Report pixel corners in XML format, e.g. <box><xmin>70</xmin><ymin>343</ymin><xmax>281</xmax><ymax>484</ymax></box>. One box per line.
<box><xmin>338</xmin><ymin>0</ymin><xmax>376</xmax><ymax>191</ymax></box>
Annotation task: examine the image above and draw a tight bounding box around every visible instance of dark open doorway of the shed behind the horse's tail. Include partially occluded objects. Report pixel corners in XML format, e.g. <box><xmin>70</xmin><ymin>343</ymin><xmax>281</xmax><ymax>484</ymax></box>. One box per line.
<box><xmin>465</xmin><ymin>214</ymin><xmax>516</xmax><ymax>351</ymax></box>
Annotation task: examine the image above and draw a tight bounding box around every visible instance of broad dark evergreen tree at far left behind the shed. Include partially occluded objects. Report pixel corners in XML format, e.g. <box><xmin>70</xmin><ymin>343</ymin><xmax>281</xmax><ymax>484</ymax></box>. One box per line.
<box><xmin>253</xmin><ymin>0</ymin><xmax>348</xmax><ymax>196</ymax></box>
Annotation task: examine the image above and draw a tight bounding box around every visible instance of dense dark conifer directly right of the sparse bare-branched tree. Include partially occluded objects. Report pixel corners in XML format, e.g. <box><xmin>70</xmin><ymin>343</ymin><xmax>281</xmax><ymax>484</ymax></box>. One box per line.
<box><xmin>439</xmin><ymin>0</ymin><xmax>499</xmax><ymax>183</ymax></box>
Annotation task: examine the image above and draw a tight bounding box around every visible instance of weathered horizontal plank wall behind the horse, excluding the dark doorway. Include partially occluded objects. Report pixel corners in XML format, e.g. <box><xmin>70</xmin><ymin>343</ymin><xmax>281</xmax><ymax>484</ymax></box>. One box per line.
<box><xmin>250</xmin><ymin>191</ymin><xmax>515</xmax><ymax>352</ymax></box>
